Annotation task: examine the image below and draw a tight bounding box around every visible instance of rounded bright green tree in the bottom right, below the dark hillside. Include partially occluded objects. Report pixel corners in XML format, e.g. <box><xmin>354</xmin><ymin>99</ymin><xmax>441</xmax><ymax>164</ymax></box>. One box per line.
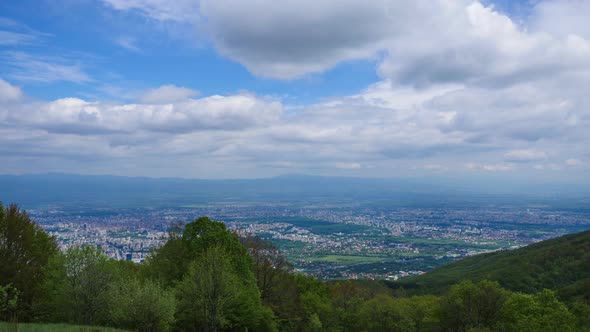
<box><xmin>502</xmin><ymin>290</ymin><xmax>576</xmax><ymax>332</ymax></box>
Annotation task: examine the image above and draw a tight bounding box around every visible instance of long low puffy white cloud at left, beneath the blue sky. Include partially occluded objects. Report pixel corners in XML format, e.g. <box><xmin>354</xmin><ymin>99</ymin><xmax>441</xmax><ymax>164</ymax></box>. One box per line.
<box><xmin>5</xmin><ymin>95</ymin><xmax>281</xmax><ymax>135</ymax></box>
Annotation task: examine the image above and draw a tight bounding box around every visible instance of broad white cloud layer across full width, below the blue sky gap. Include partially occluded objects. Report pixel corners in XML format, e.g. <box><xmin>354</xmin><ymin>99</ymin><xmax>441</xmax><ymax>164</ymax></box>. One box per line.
<box><xmin>0</xmin><ymin>68</ymin><xmax>590</xmax><ymax>177</ymax></box>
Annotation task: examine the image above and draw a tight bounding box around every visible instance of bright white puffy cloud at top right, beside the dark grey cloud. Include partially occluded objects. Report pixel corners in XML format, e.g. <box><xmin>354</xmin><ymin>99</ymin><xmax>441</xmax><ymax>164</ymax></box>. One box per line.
<box><xmin>379</xmin><ymin>1</ymin><xmax>590</xmax><ymax>86</ymax></box>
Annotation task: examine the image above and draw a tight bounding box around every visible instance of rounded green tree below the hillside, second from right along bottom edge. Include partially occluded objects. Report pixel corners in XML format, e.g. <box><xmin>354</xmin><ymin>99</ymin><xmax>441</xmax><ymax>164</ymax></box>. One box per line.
<box><xmin>440</xmin><ymin>280</ymin><xmax>507</xmax><ymax>331</ymax></box>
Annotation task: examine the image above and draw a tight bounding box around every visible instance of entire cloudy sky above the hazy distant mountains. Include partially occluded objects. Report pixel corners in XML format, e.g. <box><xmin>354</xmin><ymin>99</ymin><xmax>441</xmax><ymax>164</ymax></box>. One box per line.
<box><xmin>0</xmin><ymin>0</ymin><xmax>590</xmax><ymax>183</ymax></box>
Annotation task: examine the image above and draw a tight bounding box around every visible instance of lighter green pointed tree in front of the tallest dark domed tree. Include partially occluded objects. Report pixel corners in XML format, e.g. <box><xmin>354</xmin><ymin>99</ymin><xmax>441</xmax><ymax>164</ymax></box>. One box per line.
<box><xmin>177</xmin><ymin>245</ymin><xmax>274</xmax><ymax>332</ymax></box>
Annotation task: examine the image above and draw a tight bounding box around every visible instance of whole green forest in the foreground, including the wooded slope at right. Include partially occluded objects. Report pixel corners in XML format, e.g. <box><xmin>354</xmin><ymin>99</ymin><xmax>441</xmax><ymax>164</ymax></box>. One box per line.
<box><xmin>0</xmin><ymin>204</ymin><xmax>590</xmax><ymax>332</ymax></box>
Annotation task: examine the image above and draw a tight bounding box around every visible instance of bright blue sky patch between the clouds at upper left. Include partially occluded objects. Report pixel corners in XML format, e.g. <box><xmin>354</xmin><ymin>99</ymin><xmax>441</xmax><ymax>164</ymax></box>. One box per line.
<box><xmin>0</xmin><ymin>0</ymin><xmax>378</xmax><ymax>103</ymax></box>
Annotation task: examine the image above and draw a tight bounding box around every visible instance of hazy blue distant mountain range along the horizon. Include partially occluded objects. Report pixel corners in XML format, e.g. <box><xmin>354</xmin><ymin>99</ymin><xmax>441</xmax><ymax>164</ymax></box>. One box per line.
<box><xmin>0</xmin><ymin>174</ymin><xmax>590</xmax><ymax>208</ymax></box>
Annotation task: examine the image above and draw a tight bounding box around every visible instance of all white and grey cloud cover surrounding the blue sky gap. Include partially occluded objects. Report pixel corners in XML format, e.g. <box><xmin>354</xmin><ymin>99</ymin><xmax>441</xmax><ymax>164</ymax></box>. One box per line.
<box><xmin>0</xmin><ymin>0</ymin><xmax>590</xmax><ymax>177</ymax></box>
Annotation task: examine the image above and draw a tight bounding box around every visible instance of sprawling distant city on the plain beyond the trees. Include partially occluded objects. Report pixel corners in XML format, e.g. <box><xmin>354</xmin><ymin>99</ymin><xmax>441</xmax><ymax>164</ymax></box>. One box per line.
<box><xmin>28</xmin><ymin>202</ymin><xmax>590</xmax><ymax>280</ymax></box>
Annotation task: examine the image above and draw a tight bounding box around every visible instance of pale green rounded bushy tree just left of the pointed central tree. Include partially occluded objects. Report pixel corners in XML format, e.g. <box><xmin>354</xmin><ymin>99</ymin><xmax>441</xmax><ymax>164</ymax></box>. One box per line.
<box><xmin>108</xmin><ymin>278</ymin><xmax>176</xmax><ymax>332</ymax></box>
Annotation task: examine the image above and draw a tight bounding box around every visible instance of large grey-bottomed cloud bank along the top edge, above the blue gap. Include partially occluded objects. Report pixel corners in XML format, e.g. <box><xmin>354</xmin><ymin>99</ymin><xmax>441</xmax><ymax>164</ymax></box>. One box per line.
<box><xmin>100</xmin><ymin>0</ymin><xmax>590</xmax><ymax>86</ymax></box>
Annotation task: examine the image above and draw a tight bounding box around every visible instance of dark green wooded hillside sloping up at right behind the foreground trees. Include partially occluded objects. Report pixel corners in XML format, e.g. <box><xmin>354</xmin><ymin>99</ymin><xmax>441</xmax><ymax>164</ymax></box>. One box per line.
<box><xmin>391</xmin><ymin>231</ymin><xmax>590</xmax><ymax>299</ymax></box>
